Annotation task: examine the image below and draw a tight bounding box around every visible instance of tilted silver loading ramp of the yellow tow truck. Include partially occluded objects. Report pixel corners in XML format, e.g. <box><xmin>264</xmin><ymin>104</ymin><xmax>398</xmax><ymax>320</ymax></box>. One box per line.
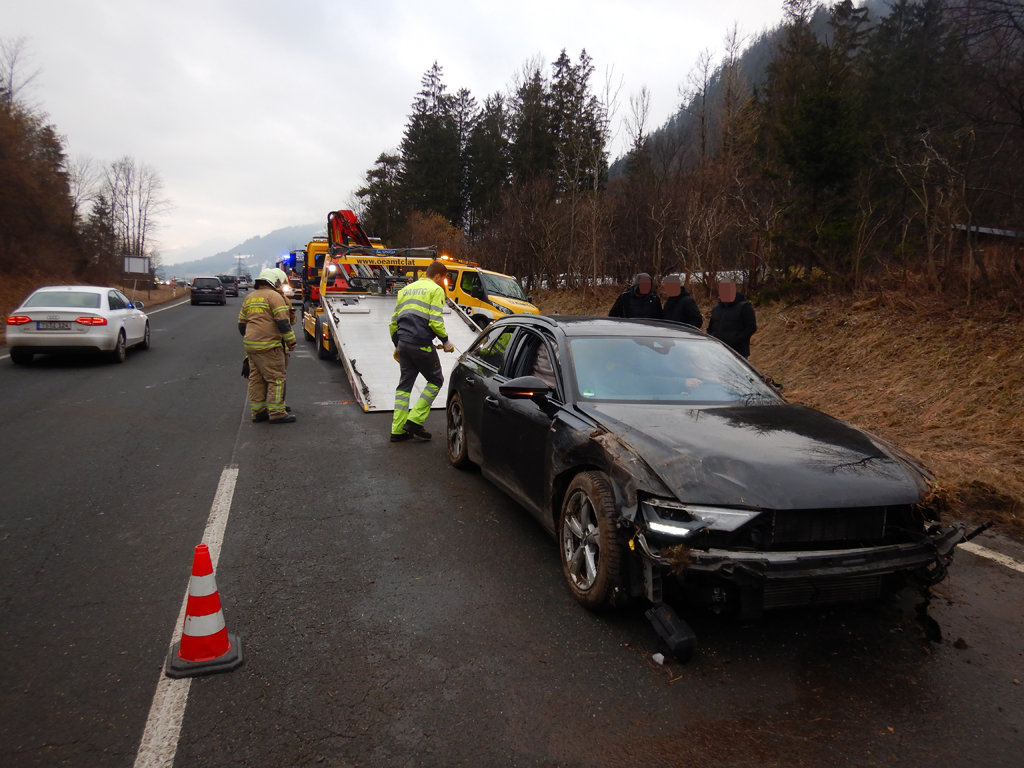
<box><xmin>322</xmin><ymin>294</ymin><xmax>479</xmax><ymax>411</ymax></box>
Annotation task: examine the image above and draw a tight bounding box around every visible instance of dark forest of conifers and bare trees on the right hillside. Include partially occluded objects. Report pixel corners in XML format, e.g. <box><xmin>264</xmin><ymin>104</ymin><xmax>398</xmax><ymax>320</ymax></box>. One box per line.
<box><xmin>357</xmin><ymin>0</ymin><xmax>1024</xmax><ymax>311</ymax></box>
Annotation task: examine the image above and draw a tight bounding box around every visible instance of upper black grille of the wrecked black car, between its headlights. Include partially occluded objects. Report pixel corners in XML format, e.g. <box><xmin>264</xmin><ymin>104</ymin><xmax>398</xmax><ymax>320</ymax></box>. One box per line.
<box><xmin>761</xmin><ymin>507</ymin><xmax>921</xmax><ymax>549</ymax></box>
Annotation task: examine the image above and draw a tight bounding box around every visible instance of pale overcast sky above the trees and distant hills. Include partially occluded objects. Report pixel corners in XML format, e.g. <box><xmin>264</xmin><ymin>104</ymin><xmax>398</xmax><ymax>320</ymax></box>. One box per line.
<box><xmin>0</xmin><ymin>0</ymin><xmax>782</xmax><ymax>264</ymax></box>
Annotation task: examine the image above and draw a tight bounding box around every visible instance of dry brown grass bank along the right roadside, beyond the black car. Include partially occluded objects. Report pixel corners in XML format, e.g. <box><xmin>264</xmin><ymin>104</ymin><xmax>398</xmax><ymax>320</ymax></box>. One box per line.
<box><xmin>534</xmin><ymin>289</ymin><xmax>1024</xmax><ymax>539</ymax></box>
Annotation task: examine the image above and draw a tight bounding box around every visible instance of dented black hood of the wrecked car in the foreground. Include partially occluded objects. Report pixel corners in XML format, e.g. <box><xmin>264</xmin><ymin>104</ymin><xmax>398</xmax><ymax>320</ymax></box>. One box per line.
<box><xmin>580</xmin><ymin>402</ymin><xmax>928</xmax><ymax>509</ymax></box>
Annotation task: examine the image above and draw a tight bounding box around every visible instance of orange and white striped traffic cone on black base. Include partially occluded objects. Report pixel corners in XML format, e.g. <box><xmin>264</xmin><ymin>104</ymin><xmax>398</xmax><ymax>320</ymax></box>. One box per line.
<box><xmin>164</xmin><ymin>544</ymin><xmax>242</xmax><ymax>678</ymax></box>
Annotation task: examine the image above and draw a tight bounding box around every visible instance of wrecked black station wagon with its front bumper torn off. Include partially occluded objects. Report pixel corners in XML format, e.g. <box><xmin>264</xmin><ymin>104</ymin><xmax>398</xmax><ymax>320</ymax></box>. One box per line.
<box><xmin>446</xmin><ymin>315</ymin><xmax>965</xmax><ymax>656</ymax></box>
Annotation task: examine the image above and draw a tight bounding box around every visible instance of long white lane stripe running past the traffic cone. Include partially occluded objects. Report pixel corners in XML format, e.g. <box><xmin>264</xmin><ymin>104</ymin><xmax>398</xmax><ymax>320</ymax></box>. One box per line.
<box><xmin>135</xmin><ymin>467</ymin><xmax>239</xmax><ymax>768</ymax></box>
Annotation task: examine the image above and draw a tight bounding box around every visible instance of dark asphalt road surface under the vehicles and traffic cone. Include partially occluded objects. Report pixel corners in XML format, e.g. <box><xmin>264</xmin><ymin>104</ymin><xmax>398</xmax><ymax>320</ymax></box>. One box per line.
<box><xmin>0</xmin><ymin>297</ymin><xmax>1024</xmax><ymax>768</ymax></box>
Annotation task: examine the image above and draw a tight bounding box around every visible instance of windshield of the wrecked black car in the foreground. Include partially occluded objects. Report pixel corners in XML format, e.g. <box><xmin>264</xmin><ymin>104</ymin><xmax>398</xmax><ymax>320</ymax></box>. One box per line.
<box><xmin>569</xmin><ymin>336</ymin><xmax>779</xmax><ymax>404</ymax></box>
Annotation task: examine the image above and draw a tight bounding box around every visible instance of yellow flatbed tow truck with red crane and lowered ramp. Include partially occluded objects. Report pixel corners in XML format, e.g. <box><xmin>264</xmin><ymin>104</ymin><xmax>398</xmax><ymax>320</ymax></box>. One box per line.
<box><xmin>302</xmin><ymin>212</ymin><xmax>479</xmax><ymax>412</ymax></box>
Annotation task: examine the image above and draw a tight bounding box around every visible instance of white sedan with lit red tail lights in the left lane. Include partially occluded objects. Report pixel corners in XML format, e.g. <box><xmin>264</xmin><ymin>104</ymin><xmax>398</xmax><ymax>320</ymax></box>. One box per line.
<box><xmin>7</xmin><ymin>286</ymin><xmax>150</xmax><ymax>365</ymax></box>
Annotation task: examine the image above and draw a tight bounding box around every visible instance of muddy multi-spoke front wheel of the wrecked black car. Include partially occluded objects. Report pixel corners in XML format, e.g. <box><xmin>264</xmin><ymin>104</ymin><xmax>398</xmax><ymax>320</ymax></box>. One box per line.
<box><xmin>558</xmin><ymin>472</ymin><xmax>626</xmax><ymax>608</ymax></box>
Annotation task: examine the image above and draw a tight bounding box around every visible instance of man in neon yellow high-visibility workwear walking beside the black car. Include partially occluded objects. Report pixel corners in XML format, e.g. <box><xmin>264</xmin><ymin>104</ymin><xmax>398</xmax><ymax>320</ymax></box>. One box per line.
<box><xmin>388</xmin><ymin>261</ymin><xmax>455</xmax><ymax>442</ymax></box>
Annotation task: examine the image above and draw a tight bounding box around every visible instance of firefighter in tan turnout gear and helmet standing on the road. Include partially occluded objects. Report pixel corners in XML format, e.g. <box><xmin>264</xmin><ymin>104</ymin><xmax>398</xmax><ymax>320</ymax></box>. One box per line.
<box><xmin>239</xmin><ymin>269</ymin><xmax>295</xmax><ymax>424</ymax></box>
